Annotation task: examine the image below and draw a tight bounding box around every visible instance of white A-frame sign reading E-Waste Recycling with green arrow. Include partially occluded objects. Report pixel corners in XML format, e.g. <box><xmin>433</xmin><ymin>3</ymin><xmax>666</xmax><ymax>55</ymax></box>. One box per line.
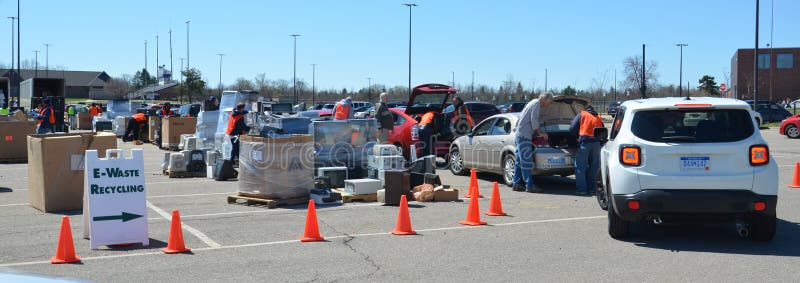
<box><xmin>83</xmin><ymin>149</ymin><xmax>150</xmax><ymax>249</ymax></box>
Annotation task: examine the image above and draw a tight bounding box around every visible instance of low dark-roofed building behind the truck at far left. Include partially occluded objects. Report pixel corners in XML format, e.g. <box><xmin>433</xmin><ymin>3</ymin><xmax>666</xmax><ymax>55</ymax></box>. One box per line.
<box><xmin>0</xmin><ymin>69</ymin><xmax>111</xmax><ymax>102</ymax></box>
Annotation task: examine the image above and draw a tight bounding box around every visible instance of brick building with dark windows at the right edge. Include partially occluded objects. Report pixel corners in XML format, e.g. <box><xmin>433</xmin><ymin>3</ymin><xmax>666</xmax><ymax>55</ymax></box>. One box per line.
<box><xmin>729</xmin><ymin>47</ymin><xmax>800</xmax><ymax>102</ymax></box>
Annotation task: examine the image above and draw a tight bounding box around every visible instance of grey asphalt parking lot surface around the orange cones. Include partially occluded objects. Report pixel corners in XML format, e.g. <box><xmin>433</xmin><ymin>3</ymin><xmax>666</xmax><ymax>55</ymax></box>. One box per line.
<box><xmin>0</xmin><ymin>128</ymin><xmax>800</xmax><ymax>282</ymax></box>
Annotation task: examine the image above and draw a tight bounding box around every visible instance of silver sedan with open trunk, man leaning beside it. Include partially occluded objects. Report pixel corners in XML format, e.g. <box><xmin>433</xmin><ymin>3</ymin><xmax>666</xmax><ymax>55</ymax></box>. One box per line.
<box><xmin>449</xmin><ymin>96</ymin><xmax>588</xmax><ymax>186</ymax></box>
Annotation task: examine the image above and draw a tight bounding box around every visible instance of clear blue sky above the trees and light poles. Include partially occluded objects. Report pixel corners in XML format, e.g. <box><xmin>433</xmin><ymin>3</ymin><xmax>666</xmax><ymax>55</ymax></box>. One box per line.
<box><xmin>0</xmin><ymin>0</ymin><xmax>800</xmax><ymax>92</ymax></box>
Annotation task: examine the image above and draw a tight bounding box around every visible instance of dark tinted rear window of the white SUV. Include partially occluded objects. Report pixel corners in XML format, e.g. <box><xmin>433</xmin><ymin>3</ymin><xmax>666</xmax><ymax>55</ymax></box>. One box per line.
<box><xmin>631</xmin><ymin>109</ymin><xmax>754</xmax><ymax>143</ymax></box>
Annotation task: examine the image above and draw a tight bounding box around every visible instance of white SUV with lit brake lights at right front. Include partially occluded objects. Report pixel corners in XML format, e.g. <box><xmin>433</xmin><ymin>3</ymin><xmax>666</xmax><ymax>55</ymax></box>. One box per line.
<box><xmin>597</xmin><ymin>97</ymin><xmax>778</xmax><ymax>241</ymax></box>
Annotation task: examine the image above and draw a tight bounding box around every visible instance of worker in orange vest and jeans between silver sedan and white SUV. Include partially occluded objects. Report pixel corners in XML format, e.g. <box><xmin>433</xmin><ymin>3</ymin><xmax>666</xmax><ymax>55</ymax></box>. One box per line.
<box><xmin>569</xmin><ymin>105</ymin><xmax>605</xmax><ymax>195</ymax></box>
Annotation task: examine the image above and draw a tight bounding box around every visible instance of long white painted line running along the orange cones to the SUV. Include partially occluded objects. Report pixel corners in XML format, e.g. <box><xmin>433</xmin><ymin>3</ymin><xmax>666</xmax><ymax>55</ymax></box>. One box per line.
<box><xmin>0</xmin><ymin>215</ymin><xmax>606</xmax><ymax>267</ymax></box>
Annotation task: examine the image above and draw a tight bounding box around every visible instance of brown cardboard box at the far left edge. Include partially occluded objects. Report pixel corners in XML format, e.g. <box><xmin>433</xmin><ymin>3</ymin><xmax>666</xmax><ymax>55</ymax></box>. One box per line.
<box><xmin>0</xmin><ymin>121</ymin><xmax>37</xmax><ymax>161</ymax></box>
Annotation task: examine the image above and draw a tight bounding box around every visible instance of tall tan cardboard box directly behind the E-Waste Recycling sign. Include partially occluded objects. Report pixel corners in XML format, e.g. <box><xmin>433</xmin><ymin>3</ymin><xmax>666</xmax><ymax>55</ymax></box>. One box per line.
<box><xmin>28</xmin><ymin>132</ymin><xmax>117</xmax><ymax>212</ymax></box>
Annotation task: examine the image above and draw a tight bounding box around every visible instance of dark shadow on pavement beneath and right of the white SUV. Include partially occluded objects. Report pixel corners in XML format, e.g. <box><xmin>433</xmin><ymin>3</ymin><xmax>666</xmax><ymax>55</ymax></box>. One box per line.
<box><xmin>625</xmin><ymin>219</ymin><xmax>800</xmax><ymax>257</ymax></box>
